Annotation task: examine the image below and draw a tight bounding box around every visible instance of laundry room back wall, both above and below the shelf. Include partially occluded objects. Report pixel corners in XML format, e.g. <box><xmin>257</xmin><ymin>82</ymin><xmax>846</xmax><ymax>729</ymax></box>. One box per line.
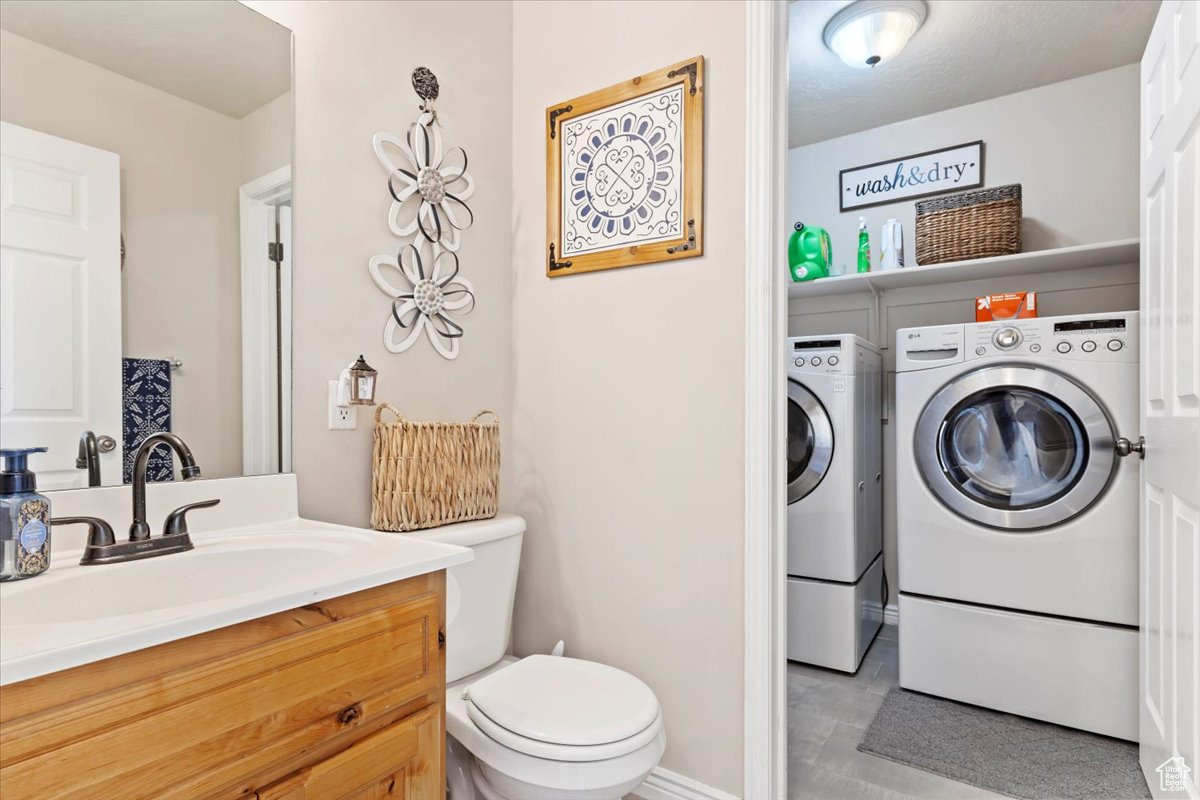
<box><xmin>787</xmin><ymin>65</ymin><xmax>1139</xmax><ymax>602</ymax></box>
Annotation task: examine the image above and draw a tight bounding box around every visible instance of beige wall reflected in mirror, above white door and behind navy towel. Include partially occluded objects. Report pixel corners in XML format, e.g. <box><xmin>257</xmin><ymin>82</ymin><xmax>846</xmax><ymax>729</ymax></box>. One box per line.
<box><xmin>0</xmin><ymin>31</ymin><xmax>241</xmax><ymax>482</ymax></box>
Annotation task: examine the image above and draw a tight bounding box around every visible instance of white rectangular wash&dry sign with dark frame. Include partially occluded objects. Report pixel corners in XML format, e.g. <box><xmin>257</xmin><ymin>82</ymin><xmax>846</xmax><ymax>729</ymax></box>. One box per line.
<box><xmin>838</xmin><ymin>142</ymin><xmax>983</xmax><ymax>211</ymax></box>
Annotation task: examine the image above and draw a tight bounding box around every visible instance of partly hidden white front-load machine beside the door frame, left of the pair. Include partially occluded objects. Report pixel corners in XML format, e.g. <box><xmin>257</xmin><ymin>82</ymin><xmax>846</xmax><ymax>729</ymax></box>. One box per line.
<box><xmin>787</xmin><ymin>333</ymin><xmax>883</xmax><ymax>672</ymax></box>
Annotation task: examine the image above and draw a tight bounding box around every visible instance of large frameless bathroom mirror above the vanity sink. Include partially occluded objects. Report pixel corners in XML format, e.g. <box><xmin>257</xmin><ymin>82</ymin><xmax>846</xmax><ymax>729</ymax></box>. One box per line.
<box><xmin>0</xmin><ymin>0</ymin><xmax>292</xmax><ymax>489</ymax></box>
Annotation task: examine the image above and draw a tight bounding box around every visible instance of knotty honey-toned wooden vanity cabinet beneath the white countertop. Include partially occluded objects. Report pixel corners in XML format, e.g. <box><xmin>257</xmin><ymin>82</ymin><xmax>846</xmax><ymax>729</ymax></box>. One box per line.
<box><xmin>0</xmin><ymin>571</ymin><xmax>445</xmax><ymax>800</ymax></box>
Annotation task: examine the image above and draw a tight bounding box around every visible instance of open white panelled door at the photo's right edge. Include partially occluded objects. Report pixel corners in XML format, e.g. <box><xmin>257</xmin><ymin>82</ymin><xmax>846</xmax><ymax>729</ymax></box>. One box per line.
<box><xmin>1140</xmin><ymin>0</ymin><xmax>1200</xmax><ymax>799</ymax></box>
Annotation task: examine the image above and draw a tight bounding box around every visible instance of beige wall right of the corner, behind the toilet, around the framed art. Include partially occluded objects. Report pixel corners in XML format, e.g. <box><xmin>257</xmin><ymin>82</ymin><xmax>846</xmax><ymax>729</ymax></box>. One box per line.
<box><xmin>512</xmin><ymin>0</ymin><xmax>745</xmax><ymax>794</ymax></box>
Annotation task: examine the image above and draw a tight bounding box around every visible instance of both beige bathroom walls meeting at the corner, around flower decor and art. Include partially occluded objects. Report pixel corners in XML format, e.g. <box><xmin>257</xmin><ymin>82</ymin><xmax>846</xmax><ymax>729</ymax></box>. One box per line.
<box><xmin>247</xmin><ymin>0</ymin><xmax>745</xmax><ymax>792</ymax></box>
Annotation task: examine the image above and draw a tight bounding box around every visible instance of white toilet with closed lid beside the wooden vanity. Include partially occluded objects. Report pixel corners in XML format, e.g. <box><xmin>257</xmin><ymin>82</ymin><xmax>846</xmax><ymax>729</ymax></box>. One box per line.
<box><xmin>415</xmin><ymin>515</ymin><xmax>666</xmax><ymax>800</ymax></box>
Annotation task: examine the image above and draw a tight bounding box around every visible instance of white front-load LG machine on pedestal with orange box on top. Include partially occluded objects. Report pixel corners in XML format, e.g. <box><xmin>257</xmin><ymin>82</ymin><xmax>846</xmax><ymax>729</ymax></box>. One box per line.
<box><xmin>895</xmin><ymin>312</ymin><xmax>1139</xmax><ymax>740</ymax></box>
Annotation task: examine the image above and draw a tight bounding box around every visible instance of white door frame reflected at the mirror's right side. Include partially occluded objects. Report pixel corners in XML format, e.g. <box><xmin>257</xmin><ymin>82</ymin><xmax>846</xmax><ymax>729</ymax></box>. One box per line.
<box><xmin>238</xmin><ymin>166</ymin><xmax>292</xmax><ymax>475</ymax></box>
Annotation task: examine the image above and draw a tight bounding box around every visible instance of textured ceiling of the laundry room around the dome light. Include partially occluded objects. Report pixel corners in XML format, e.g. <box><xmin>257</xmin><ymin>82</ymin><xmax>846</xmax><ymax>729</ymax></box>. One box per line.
<box><xmin>788</xmin><ymin>0</ymin><xmax>1159</xmax><ymax>148</ymax></box>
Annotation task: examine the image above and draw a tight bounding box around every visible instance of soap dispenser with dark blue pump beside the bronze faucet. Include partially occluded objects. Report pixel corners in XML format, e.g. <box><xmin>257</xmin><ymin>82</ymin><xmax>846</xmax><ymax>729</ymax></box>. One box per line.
<box><xmin>0</xmin><ymin>447</ymin><xmax>50</xmax><ymax>581</ymax></box>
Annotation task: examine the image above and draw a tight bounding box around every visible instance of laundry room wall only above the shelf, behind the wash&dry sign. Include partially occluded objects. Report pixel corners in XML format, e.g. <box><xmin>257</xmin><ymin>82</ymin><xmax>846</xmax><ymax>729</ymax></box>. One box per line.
<box><xmin>785</xmin><ymin>64</ymin><xmax>1138</xmax><ymax>271</ymax></box>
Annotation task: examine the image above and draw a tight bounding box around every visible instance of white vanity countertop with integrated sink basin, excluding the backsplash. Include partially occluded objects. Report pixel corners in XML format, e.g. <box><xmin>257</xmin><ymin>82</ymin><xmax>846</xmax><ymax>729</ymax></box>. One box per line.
<box><xmin>0</xmin><ymin>519</ymin><xmax>472</xmax><ymax>684</ymax></box>
